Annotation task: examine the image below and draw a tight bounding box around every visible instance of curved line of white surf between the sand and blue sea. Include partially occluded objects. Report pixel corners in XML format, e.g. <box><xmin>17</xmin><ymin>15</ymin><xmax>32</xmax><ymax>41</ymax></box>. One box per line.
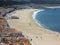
<box><xmin>32</xmin><ymin>7</ymin><xmax>60</xmax><ymax>33</ymax></box>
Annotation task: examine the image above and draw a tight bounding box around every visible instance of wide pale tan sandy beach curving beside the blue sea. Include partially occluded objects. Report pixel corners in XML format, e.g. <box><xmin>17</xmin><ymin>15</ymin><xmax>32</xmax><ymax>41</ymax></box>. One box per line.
<box><xmin>8</xmin><ymin>9</ymin><xmax>60</xmax><ymax>45</ymax></box>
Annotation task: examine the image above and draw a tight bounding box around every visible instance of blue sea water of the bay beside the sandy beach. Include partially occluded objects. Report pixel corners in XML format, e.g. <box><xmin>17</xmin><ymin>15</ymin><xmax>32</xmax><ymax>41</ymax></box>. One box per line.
<box><xmin>35</xmin><ymin>8</ymin><xmax>60</xmax><ymax>32</ymax></box>
